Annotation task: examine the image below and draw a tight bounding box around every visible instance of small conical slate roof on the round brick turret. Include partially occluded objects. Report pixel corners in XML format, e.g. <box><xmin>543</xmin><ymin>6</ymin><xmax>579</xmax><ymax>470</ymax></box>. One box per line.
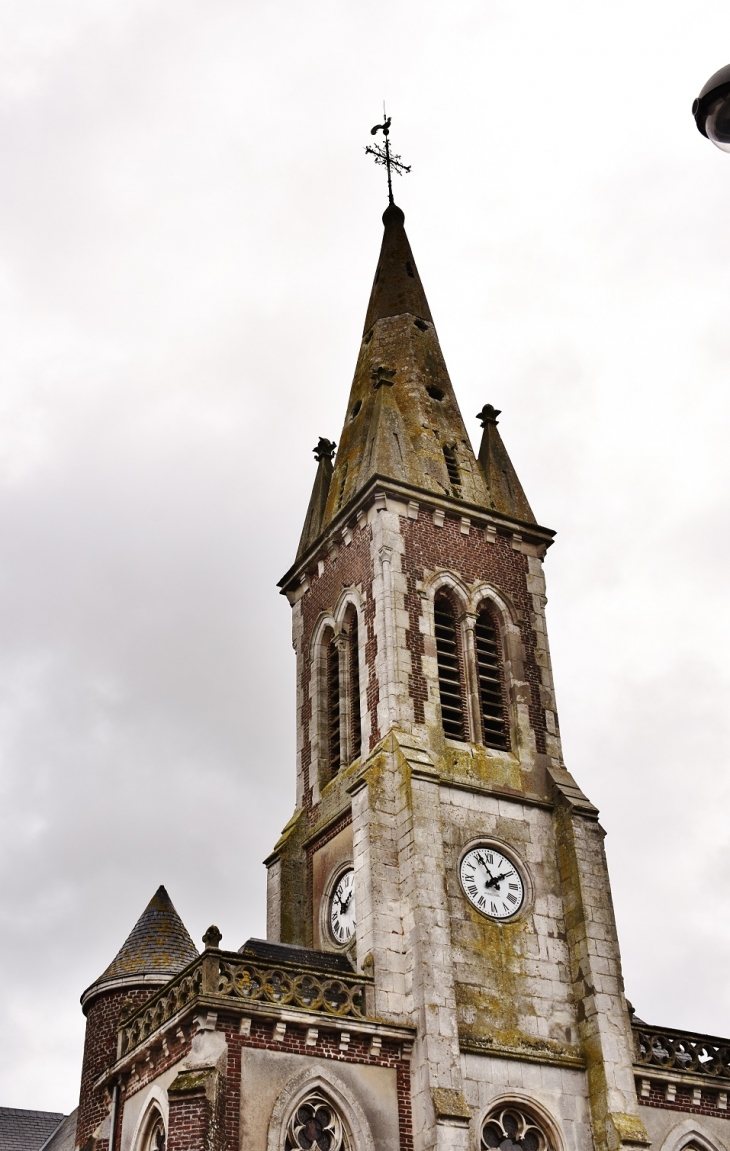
<box><xmin>83</xmin><ymin>886</ymin><xmax>198</xmax><ymax>1000</ymax></box>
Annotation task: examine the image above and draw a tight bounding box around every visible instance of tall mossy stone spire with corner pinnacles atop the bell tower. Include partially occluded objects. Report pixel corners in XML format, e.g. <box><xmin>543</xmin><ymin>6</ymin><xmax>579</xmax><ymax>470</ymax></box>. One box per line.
<box><xmin>289</xmin><ymin>204</ymin><xmax>534</xmax><ymax>568</ymax></box>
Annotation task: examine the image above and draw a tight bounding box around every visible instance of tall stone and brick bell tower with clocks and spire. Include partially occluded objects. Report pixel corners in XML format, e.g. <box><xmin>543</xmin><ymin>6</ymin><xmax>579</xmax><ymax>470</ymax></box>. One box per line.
<box><xmin>267</xmin><ymin>204</ymin><xmax>647</xmax><ymax>1151</ymax></box>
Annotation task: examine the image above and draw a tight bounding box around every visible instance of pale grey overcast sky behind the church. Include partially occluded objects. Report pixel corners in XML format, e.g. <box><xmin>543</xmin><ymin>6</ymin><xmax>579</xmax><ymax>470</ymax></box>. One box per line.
<box><xmin>0</xmin><ymin>0</ymin><xmax>730</xmax><ymax>1111</ymax></box>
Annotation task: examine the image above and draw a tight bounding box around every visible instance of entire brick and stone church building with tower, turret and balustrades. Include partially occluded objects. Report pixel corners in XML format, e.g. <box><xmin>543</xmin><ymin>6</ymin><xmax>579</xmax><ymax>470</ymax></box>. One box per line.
<box><xmin>63</xmin><ymin>170</ymin><xmax>730</xmax><ymax>1151</ymax></box>
